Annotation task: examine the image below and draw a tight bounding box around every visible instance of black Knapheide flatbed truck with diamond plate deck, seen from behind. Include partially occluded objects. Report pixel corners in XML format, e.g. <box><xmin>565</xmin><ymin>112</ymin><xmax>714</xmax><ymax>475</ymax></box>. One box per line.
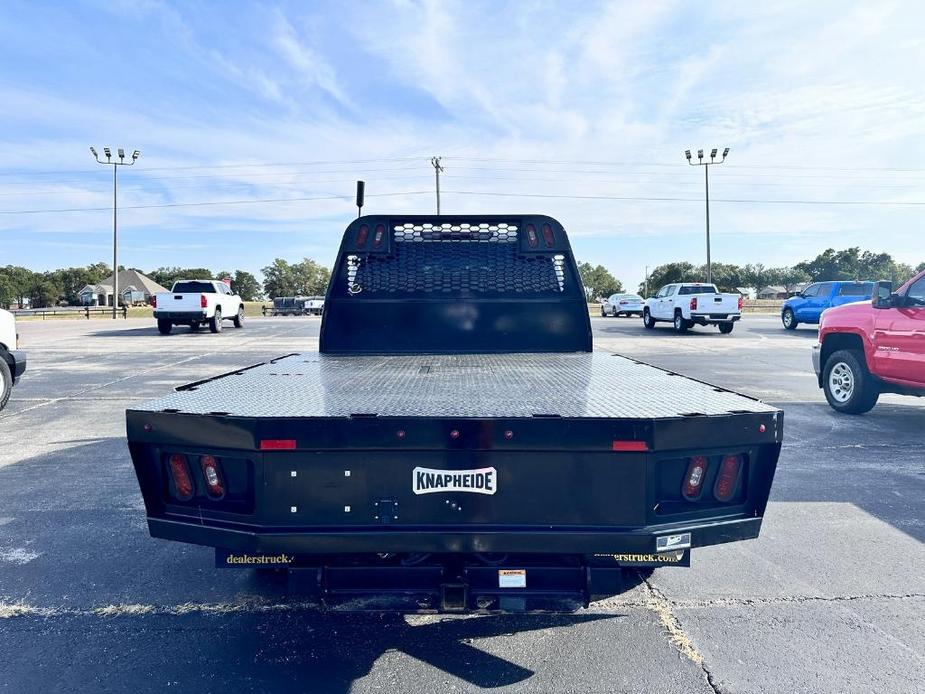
<box><xmin>127</xmin><ymin>215</ymin><xmax>783</xmax><ymax>611</ymax></box>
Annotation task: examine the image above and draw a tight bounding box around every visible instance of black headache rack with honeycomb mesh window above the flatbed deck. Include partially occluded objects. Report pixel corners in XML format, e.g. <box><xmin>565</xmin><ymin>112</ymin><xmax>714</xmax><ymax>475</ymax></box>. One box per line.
<box><xmin>320</xmin><ymin>215</ymin><xmax>591</xmax><ymax>354</ymax></box>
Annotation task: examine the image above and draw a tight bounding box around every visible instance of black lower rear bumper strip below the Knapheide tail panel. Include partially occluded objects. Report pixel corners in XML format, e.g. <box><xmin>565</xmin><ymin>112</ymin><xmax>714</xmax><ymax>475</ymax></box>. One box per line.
<box><xmin>148</xmin><ymin>518</ymin><xmax>761</xmax><ymax>555</ymax></box>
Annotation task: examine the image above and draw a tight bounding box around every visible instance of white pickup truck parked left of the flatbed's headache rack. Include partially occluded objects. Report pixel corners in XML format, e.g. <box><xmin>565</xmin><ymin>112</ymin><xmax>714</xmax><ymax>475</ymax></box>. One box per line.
<box><xmin>152</xmin><ymin>280</ymin><xmax>244</xmax><ymax>335</ymax></box>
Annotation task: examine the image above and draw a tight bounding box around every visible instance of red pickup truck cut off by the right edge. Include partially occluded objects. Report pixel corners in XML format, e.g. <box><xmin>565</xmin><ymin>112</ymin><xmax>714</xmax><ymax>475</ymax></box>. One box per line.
<box><xmin>813</xmin><ymin>272</ymin><xmax>925</xmax><ymax>414</ymax></box>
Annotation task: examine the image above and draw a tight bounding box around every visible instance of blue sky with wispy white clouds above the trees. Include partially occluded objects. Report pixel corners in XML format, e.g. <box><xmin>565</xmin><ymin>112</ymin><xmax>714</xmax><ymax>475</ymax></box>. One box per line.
<box><xmin>0</xmin><ymin>0</ymin><xmax>925</xmax><ymax>287</ymax></box>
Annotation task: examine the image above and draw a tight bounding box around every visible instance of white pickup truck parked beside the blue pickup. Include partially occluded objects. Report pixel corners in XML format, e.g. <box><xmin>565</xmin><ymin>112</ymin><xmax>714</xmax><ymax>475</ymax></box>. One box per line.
<box><xmin>642</xmin><ymin>282</ymin><xmax>742</xmax><ymax>334</ymax></box>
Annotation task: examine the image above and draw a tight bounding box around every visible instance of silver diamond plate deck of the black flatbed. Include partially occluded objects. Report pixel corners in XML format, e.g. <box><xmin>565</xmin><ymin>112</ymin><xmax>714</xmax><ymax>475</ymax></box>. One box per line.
<box><xmin>132</xmin><ymin>352</ymin><xmax>777</xmax><ymax>419</ymax></box>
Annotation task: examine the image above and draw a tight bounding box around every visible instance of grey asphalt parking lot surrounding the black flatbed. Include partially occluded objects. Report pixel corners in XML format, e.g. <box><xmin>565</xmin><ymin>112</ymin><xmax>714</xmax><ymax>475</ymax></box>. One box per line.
<box><xmin>0</xmin><ymin>316</ymin><xmax>925</xmax><ymax>693</ymax></box>
